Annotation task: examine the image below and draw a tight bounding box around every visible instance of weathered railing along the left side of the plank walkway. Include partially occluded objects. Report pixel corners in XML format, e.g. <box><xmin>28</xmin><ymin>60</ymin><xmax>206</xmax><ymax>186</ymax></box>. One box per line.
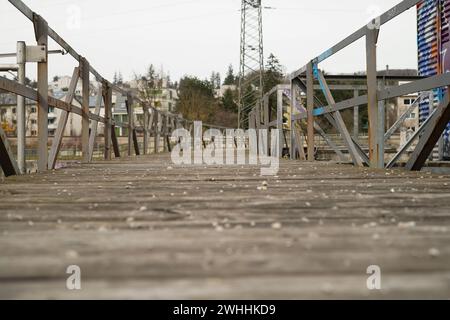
<box><xmin>0</xmin><ymin>0</ymin><xmax>229</xmax><ymax>176</ymax></box>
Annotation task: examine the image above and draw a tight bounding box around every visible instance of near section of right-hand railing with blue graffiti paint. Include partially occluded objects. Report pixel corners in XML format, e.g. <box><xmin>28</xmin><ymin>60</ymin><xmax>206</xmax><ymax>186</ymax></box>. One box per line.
<box><xmin>290</xmin><ymin>0</ymin><xmax>450</xmax><ymax>170</ymax></box>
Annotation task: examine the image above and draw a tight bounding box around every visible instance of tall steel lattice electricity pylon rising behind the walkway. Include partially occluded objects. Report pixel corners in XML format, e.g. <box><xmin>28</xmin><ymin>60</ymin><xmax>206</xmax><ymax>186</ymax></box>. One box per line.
<box><xmin>238</xmin><ymin>0</ymin><xmax>264</xmax><ymax>128</ymax></box>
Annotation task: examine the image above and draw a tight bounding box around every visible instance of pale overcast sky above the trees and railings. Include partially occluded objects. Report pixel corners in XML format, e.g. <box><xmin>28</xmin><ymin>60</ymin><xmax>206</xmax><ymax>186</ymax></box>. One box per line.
<box><xmin>0</xmin><ymin>0</ymin><xmax>417</xmax><ymax>80</ymax></box>
